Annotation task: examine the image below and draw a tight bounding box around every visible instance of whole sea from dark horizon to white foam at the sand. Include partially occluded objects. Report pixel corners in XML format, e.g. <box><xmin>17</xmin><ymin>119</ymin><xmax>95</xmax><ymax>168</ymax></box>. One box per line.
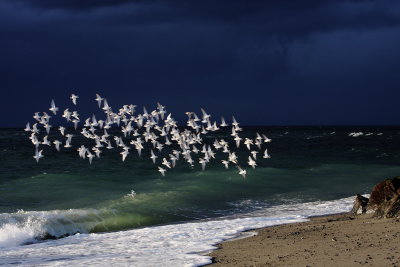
<box><xmin>0</xmin><ymin>126</ymin><xmax>400</xmax><ymax>266</ymax></box>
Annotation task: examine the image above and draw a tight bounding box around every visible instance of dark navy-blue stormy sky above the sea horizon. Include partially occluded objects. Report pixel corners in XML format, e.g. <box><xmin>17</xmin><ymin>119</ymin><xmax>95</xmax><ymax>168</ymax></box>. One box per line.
<box><xmin>0</xmin><ymin>0</ymin><xmax>400</xmax><ymax>127</ymax></box>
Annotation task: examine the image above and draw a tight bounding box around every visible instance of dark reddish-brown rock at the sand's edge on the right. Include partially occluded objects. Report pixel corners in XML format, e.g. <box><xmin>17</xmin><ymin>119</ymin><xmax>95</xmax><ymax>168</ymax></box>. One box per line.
<box><xmin>352</xmin><ymin>177</ymin><xmax>400</xmax><ymax>218</ymax></box>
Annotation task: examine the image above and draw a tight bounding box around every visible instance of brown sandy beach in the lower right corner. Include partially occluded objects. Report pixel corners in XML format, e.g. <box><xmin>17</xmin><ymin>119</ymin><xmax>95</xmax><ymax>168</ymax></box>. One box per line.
<box><xmin>209</xmin><ymin>214</ymin><xmax>400</xmax><ymax>267</ymax></box>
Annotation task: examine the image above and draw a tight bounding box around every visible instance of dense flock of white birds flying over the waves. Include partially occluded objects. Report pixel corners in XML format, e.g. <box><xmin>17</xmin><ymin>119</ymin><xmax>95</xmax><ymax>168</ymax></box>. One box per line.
<box><xmin>25</xmin><ymin>94</ymin><xmax>271</xmax><ymax>178</ymax></box>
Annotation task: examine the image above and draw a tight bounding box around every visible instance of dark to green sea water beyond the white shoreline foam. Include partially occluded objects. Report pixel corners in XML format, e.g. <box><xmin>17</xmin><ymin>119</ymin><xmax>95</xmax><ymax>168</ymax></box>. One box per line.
<box><xmin>0</xmin><ymin>127</ymin><xmax>400</xmax><ymax>238</ymax></box>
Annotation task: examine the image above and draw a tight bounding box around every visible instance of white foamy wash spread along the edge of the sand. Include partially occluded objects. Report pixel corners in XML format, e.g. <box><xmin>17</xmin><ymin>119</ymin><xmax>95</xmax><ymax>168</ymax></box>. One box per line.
<box><xmin>0</xmin><ymin>198</ymin><xmax>353</xmax><ymax>266</ymax></box>
